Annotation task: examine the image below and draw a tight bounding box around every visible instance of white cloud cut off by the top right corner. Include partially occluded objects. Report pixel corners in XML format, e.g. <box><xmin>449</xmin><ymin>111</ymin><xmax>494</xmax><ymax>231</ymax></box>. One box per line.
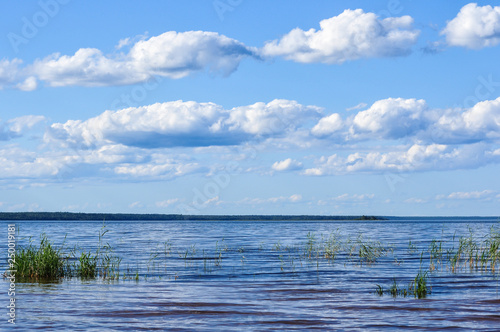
<box><xmin>441</xmin><ymin>3</ymin><xmax>500</xmax><ymax>49</ymax></box>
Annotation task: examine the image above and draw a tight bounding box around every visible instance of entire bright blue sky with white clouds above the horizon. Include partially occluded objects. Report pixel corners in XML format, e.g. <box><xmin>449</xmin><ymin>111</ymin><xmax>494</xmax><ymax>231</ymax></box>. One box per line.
<box><xmin>0</xmin><ymin>0</ymin><xmax>500</xmax><ymax>215</ymax></box>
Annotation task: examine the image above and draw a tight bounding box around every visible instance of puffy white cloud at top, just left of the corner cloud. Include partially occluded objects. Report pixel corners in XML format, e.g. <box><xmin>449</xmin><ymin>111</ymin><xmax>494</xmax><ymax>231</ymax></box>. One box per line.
<box><xmin>262</xmin><ymin>9</ymin><xmax>419</xmax><ymax>64</ymax></box>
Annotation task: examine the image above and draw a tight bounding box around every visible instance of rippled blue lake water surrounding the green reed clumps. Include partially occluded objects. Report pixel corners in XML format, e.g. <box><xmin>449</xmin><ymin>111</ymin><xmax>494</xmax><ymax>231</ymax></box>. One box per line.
<box><xmin>0</xmin><ymin>218</ymin><xmax>500</xmax><ymax>331</ymax></box>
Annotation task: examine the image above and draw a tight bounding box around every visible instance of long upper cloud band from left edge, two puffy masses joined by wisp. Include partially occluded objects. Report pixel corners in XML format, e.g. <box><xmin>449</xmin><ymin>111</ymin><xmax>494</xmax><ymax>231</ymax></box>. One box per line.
<box><xmin>0</xmin><ymin>9</ymin><xmax>426</xmax><ymax>91</ymax></box>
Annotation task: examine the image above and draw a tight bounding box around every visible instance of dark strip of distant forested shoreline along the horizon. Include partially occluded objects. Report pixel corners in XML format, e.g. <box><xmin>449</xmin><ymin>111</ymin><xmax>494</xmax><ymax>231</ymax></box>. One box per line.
<box><xmin>0</xmin><ymin>212</ymin><xmax>386</xmax><ymax>221</ymax></box>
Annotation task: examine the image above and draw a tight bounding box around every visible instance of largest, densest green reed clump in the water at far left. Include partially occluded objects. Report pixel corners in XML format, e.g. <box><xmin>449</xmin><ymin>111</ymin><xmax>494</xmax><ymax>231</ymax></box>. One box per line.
<box><xmin>15</xmin><ymin>234</ymin><xmax>71</xmax><ymax>279</ymax></box>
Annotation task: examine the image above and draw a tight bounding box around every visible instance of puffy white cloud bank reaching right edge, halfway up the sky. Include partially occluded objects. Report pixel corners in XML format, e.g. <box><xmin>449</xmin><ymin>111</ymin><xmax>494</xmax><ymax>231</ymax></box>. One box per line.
<box><xmin>311</xmin><ymin>97</ymin><xmax>500</xmax><ymax>144</ymax></box>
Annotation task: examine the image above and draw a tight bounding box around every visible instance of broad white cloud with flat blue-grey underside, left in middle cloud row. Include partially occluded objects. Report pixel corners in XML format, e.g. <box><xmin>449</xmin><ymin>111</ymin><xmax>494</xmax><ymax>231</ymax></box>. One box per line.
<box><xmin>46</xmin><ymin>101</ymin><xmax>227</xmax><ymax>147</ymax></box>
